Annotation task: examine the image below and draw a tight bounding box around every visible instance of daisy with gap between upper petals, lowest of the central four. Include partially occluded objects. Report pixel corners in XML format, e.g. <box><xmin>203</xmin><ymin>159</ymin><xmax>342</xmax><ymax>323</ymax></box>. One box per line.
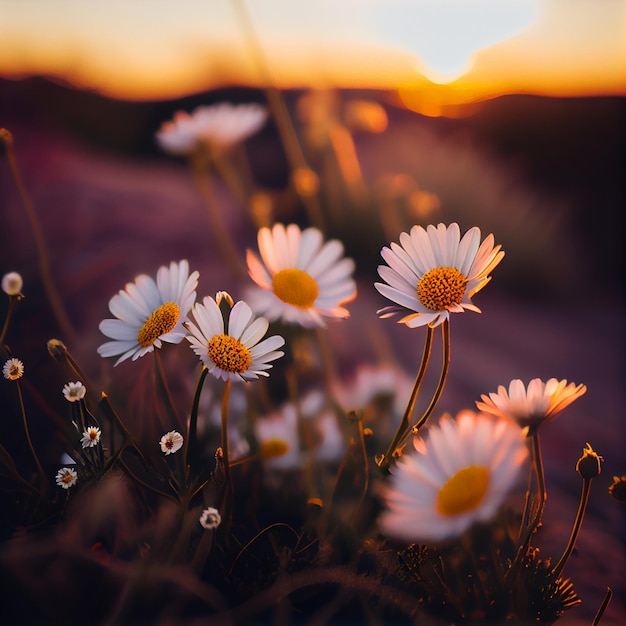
<box><xmin>186</xmin><ymin>296</ymin><xmax>285</xmax><ymax>380</ymax></box>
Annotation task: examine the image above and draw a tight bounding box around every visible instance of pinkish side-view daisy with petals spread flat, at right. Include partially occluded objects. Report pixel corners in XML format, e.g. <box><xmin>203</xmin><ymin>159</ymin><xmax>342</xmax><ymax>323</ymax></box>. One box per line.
<box><xmin>476</xmin><ymin>378</ymin><xmax>587</xmax><ymax>429</ymax></box>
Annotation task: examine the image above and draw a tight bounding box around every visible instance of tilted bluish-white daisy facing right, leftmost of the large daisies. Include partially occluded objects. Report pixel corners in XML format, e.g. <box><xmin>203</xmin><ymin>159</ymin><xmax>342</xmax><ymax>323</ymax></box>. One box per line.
<box><xmin>98</xmin><ymin>260</ymin><xmax>198</xmax><ymax>365</ymax></box>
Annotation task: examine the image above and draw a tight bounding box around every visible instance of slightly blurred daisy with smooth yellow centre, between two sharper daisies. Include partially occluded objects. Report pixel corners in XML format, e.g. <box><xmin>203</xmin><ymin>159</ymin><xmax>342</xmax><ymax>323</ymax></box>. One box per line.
<box><xmin>247</xmin><ymin>224</ymin><xmax>356</xmax><ymax>328</ymax></box>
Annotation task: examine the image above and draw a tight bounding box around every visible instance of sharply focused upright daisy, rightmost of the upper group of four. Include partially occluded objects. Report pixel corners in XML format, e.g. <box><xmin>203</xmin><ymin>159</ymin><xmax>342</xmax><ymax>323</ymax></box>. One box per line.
<box><xmin>374</xmin><ymin>224</ymin><xmax>504</xmax><ymax>328</ymax></box>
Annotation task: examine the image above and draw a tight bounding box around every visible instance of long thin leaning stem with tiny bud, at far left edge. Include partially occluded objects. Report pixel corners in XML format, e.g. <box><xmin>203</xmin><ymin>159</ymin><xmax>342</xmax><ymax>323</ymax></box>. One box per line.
<box><xmin>0</xmin><ymin>128</ymin><xmax>76</xmax><ymax>343</ymax></box>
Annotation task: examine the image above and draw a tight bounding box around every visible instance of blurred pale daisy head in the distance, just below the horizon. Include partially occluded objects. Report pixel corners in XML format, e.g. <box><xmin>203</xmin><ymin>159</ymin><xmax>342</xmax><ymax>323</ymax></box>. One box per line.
<box><xmin>156</xmin><ymin>102</ymin><xmax>267</xmax><ymax>155</ymax></box>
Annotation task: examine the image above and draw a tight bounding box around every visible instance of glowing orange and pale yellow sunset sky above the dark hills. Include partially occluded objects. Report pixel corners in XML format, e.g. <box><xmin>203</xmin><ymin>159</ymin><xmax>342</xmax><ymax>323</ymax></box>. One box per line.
<box><xmin>0</xmin><ymin>0</ymin><xmax>626</xmax><ymax>112</ymax></box>
